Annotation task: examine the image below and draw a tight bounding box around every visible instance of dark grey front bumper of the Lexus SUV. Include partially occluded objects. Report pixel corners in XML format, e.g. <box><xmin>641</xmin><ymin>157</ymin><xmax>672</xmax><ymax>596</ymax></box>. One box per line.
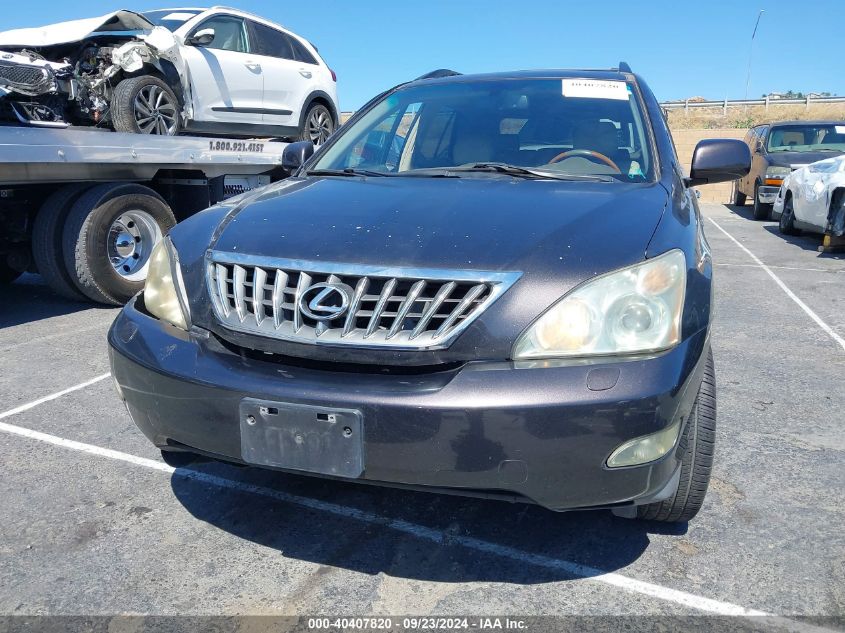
<box><xmin>109</xmin><ymin>300</ymin><xmax>709</xmax><ymax>510</ymax></box>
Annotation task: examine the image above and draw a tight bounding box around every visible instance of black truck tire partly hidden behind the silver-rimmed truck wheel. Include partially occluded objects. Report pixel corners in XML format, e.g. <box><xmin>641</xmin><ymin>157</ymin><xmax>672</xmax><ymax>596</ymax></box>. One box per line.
<box><xmin>32</xmin><ymin>184</ymin><xmax>88</xmax><ymax>301</ymax></box>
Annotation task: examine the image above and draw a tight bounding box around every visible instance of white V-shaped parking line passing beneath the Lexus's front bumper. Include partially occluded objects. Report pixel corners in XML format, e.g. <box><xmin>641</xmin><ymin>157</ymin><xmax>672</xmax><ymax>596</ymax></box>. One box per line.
<box><xmin>0</xmin><ymin>374</ymin><xmax>830</xmax><ymax>631</ymax></box>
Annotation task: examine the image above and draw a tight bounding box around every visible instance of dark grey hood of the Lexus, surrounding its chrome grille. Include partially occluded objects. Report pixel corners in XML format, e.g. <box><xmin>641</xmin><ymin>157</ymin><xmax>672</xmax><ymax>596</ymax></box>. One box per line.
<box><xmin>193</xmin><ymin>177</ymin><xmax>668</xmax><ymax>365</ymax></box>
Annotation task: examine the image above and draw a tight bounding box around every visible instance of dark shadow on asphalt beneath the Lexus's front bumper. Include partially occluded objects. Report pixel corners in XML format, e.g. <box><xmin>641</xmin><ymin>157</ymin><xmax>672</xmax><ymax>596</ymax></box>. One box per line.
<box><xmin>171</xmin><ymin>463</ymin><xmax>687</xmax><ymax>584</ymax></box>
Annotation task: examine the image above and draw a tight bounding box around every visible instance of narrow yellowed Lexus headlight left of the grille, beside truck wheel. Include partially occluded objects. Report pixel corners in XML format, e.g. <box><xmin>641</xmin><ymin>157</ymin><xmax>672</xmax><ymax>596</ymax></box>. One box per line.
<box><xmin>144</xmin><ymin>238</ymin><xmax>188</xmax><ymax>330</ymax></box>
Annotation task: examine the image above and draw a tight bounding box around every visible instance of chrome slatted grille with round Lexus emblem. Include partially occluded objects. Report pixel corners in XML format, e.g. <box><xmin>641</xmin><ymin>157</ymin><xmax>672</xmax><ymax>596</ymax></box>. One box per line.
<box><xmin>206</xmin><ymin>251</ymin><xmax>520</xmax><ymax>349</ymax></box>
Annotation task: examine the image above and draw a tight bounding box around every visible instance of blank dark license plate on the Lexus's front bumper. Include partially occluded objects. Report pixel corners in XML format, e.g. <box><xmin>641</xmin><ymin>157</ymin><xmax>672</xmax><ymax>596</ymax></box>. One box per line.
<box><xmin>240</xmin><ymin>398</ymin><xmax>364</xmax><ymax>478</ymax></box>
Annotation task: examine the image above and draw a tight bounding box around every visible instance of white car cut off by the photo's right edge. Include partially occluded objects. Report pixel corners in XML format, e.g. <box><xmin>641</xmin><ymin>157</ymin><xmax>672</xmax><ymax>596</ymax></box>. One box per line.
<box><xmin>772</xmin><ymin>154</ymin><xmax>845</xmax><ymax>237</ymax></box>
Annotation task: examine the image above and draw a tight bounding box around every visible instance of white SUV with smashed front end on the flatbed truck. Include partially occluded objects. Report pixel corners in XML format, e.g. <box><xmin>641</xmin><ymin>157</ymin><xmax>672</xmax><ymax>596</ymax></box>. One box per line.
<box><xmin>0</xmin><ymin>7</ymin><xmax>339</xmax><ymax>138</ymax></box>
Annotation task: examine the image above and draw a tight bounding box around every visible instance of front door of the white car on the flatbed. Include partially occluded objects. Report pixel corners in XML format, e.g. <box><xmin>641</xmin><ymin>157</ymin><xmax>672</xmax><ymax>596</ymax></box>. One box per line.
<box><xmin>182</xmin><ymin>14</ymin><xmax>264</xmax><ymax>124</ymax></box>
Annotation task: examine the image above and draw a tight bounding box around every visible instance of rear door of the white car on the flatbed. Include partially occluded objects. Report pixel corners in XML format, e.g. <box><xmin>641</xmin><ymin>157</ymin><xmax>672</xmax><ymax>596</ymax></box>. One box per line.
<box><xmin>249</xmin><ymin>20</ymin><xmax>316</xmax><ymax>126</ymax></box>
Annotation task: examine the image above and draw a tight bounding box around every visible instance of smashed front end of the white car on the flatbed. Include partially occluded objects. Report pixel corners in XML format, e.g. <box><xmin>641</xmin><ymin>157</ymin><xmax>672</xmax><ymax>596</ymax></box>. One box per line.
<box><xmin>0</xmin><ymin>11</ymin><xmax>190</xmax><ymax>126</ymax></box>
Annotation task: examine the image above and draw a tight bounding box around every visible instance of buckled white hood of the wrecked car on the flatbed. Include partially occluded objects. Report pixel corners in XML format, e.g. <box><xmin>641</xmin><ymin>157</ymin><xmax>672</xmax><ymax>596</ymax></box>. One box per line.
<box><xmin>0</xmin><ymin>10</ymin><xmax>153</xmax><ymax>48</ymax></box>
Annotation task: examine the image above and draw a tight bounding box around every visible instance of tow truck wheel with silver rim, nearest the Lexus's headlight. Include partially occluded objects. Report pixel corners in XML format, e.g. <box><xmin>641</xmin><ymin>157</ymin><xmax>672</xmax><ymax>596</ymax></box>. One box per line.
<box><xmin>62</xmin><ymin>183</ymin><xmax>176</xmax><ymax>305</ymax></box>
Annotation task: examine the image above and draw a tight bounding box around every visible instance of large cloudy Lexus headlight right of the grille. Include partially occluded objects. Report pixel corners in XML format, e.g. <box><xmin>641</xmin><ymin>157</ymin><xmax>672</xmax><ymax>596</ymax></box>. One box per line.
<box><xmin>513</xmin><ymin>250</ymin><xmax>686</xmax><ymax>359</ymax></box>
